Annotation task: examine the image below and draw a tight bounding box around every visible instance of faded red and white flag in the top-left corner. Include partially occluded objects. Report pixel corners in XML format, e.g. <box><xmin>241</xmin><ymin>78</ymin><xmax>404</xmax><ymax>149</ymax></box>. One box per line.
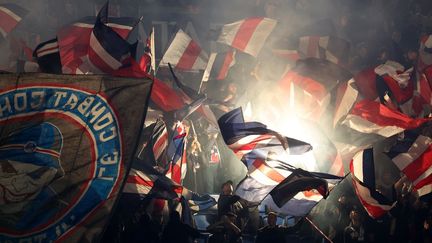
<box><xmin>0</xmin><ymin>3</ymin><xmax>28</xmax><ymax>39</ymax></box>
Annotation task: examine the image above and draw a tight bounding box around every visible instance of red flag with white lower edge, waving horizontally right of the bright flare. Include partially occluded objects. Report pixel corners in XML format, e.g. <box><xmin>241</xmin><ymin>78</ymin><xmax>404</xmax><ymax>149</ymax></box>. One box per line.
<box><xmin>341</xmin><ymin>100</ymin><xmax>428</xmax><ymax>137</ymax></box>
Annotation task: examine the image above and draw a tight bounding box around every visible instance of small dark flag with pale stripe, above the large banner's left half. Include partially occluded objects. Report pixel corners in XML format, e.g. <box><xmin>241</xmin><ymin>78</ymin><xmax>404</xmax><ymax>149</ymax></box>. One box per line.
<box><xmin>33</xmin><ymin>38</ymin><xmax>62</xmax><ymax>74</ymax></box>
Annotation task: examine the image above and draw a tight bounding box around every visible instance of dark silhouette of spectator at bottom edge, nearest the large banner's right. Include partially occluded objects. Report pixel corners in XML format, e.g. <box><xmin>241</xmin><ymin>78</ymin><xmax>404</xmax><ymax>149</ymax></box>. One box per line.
<box><xmin>161</xmin><ymin>211</ymin><xmax>201</xmax><ymax>243</ymax></box>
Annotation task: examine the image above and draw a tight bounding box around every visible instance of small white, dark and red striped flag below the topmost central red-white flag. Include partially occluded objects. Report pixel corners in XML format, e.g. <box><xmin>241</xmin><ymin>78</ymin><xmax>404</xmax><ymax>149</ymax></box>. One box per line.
<box><xmin>202</xmin><ymin>51</ymin><xmax>235</xmax><ymax>82</ymax></box>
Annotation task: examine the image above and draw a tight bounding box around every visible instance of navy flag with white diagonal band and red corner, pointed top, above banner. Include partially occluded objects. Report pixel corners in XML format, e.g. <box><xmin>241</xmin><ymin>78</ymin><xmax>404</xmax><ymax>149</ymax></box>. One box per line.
<box><xmin>88</xmin><ymin>5</ymin><xmax>133</xmax><ymax>73</ymax></box>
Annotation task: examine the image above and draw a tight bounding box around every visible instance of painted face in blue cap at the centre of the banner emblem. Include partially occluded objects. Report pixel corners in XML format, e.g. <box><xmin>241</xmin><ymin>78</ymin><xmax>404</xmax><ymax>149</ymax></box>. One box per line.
<box><xmin>0</xmin><ymin>122</ymin><xmax>65</xmax><ymax>229</ymax></box>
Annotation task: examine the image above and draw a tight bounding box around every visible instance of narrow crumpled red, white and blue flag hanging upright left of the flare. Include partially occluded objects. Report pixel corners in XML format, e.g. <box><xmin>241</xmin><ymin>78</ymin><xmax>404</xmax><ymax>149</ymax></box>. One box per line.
<box><xmin>165</xmin><ymin>122</ymin><xmax>187</xmax><ymax>184</ymax></box>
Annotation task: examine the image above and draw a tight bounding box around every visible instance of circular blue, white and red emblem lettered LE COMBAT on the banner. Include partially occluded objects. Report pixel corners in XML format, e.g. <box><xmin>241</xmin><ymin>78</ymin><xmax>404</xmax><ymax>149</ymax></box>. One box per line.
<box><xmin>0</xmin><ymin>85</ymin><xmax>122</xmax><ymax>242</ymax></box>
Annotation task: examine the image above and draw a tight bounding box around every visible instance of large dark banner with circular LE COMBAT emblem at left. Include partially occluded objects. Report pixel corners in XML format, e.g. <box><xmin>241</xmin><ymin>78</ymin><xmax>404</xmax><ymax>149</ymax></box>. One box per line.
<box><xmin>0</xmin><ymin>74</ymin><xmax>152</xmax><ymax>242</ymax></box>
